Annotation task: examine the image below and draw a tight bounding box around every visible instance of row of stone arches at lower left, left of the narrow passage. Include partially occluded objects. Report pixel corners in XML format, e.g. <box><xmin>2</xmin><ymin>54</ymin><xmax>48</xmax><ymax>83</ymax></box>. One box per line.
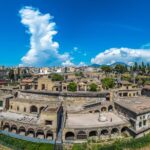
<box><xmin>3</xmin><ymin>123</ymin><xmax>53</xmax><ymax>140</ymax></box>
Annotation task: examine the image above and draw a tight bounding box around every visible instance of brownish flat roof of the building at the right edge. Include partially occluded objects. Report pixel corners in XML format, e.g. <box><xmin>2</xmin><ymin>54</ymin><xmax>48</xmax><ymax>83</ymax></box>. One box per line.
<box><xmin>115</xmin><ymin>96</ymin><xmax>150</xmax><ymax>114</ymax></box>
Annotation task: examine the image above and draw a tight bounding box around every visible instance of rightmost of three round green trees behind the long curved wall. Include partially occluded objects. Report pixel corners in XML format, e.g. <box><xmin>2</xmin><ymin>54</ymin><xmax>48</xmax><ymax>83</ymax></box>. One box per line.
<box><xmin>102</xmin><ymin>78</ymin><xmax>115</xmax><ymax>89</ymax></box>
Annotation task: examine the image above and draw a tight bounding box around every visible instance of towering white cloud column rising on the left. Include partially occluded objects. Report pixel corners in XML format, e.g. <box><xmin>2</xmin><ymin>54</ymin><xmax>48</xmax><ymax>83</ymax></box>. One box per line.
<box><xmin>19</xmin><ymin>7</ymin><xmax>70</xmax><ymax>66</ymax></box>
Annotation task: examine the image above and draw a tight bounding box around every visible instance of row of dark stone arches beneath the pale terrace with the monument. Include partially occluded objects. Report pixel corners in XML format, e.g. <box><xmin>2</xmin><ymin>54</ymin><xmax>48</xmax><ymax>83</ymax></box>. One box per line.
<box><xmin>65</xmin><ymin>127</ymin><xmax>128</xmax><ymax>140</ymax></box>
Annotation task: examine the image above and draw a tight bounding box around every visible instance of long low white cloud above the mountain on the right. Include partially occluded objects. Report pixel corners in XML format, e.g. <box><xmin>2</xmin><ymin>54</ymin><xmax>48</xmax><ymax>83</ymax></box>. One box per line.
<box><xmin>91</xmin><ymin>48</ymin><xmax>150</xmax><ymax>65</ymax></box>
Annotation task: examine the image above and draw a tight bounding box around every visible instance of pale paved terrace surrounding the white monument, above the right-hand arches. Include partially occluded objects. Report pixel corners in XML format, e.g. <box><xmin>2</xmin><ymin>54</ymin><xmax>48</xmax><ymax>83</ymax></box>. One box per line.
<box><xmin>65</xmin><ymin>112</ymin><xmax>127</xmax><ymax>128</ymax></box>
